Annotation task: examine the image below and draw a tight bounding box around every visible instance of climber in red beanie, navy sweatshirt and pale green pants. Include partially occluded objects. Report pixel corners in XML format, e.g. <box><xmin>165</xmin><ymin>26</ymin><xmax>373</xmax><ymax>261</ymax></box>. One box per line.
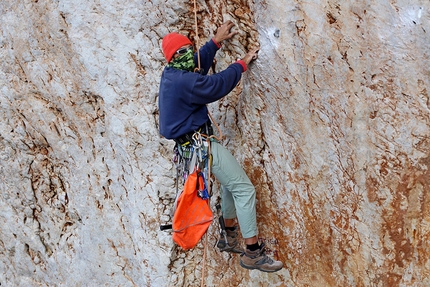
<box><xmin>158</xmin><ymin>21</ymin><xmax>283</xmax><ymax>272</ymax></box>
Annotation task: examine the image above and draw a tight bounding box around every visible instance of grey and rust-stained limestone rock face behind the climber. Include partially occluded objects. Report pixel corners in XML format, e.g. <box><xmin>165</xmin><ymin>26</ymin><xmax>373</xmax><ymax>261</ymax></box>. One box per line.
<box><xmin>0</xmin><ymin>0</ymin><xmax>430</xmax><ymax>286</ymax></box>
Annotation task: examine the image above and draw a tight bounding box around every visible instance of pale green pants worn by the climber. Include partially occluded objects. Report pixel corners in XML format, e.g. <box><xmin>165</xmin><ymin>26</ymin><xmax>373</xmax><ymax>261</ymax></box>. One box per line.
<box><xmin>211</xmin><ymin>141</ymin><xmax>257</xmax><ymax>238</ymax></box>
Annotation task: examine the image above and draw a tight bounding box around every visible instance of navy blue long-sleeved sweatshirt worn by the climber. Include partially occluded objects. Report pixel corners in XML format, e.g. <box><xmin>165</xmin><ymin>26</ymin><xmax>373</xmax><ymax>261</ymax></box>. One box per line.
<box><xmin>158</xmin><ymin>40</ymin><xmax>246</xmax><ymax>139</ymax></box>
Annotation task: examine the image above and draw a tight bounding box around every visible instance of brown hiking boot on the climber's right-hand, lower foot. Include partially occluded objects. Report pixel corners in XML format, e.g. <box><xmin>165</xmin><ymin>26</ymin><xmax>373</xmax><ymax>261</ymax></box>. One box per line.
<box><xmin>240</xmin><ymin>243</ymin><xmax>284</xmax><ymax>272</ymax></box>
